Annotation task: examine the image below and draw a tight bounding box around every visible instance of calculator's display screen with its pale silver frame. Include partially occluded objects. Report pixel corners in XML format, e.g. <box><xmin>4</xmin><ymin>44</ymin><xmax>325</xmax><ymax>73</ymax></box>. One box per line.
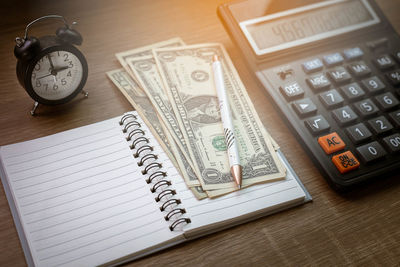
<box><xmin>240</xmin><ymin>0</ymin><xmax>379</xmax><ymax>55</ymax></box>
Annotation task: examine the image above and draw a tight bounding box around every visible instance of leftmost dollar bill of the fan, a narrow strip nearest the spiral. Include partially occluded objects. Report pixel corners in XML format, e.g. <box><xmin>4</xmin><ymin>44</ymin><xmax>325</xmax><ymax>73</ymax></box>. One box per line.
<box><xmin>107</xmin><ymin>69</ymin><xmax>203</xmax><ymax>195</ymax></box>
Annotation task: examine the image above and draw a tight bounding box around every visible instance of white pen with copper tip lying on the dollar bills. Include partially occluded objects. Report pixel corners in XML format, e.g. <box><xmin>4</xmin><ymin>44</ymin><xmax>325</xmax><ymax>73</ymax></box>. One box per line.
<box><xmin>212</xmin><ymin>55</ymin><xmax>242</xmax><ymax>189</ymax></box>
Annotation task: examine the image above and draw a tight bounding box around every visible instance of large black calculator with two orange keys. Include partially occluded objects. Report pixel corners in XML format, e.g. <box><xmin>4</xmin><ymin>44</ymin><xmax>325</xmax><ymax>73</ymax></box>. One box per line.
<box><xmin>218</xmin><ymin>0</ymin><xmax>400</xmax><ymax>190</ymax></box>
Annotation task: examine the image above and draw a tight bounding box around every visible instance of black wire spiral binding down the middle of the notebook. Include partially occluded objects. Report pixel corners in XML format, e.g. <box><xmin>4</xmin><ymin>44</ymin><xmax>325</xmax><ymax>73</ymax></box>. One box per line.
<box><xmin>119</xmin><ymin>113</ymin><xmax>191</xmax><ymax>231</ymax></box>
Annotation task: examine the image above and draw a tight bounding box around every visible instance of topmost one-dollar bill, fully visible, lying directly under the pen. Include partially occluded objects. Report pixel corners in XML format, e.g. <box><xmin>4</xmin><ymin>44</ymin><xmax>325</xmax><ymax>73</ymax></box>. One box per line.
<box><xmin>153</xmin><ymin>44</ymin><xmax>286</xmax><ymax>191</ymax></box>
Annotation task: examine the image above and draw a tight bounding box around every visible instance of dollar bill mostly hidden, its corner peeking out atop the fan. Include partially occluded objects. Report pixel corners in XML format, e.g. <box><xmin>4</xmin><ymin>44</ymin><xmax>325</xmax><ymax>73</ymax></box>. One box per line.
<box><xmin>115</xmin><ymin>37</ymin><xmax>185</xmax><ymax>79</ymax></box>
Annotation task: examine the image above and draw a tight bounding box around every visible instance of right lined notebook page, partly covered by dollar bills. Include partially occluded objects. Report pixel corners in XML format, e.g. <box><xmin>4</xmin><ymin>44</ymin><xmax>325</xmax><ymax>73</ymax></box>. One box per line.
<box><xmin>169</xmin><ymin>153</ymin><xmax>305</xmax><ymax>238</ymax></box>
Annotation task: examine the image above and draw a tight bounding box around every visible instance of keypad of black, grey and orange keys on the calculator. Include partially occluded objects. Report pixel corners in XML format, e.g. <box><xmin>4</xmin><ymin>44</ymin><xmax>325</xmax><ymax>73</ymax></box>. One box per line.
<box><xmin>268</xmin><ymin>39</ymin><xmax>400</xmax><ymax>187</ymax></box>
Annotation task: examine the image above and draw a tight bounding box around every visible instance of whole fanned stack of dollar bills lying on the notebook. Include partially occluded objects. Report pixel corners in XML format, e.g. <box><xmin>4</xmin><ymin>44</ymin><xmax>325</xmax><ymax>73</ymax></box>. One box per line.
<box><xmin>107</xmin><ymin>38</ymin><xmax>286</xmax><ymax>199</ymax></box>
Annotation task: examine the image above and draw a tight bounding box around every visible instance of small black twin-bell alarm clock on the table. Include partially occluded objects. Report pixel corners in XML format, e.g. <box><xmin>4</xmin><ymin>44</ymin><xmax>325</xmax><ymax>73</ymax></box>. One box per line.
<box><xmin>14</xmin><ymin>15</ymin><xmax>88</xmax><ymax>115</ymax></box>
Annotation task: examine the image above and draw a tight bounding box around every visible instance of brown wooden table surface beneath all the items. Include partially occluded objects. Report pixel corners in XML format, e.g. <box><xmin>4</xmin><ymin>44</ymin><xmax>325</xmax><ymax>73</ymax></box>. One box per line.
<box><xmin>0</xmin><ymin>0</ymin><xmax>400</xmax><ymax>266</ymax></box>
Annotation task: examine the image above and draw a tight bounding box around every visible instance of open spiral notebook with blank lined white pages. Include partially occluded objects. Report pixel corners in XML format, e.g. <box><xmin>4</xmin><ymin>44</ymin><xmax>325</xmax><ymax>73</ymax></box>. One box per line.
<box><xmin>0</xmin><ymin>112</ymin><xmax>310</xmax><ymax>266</ymax></box>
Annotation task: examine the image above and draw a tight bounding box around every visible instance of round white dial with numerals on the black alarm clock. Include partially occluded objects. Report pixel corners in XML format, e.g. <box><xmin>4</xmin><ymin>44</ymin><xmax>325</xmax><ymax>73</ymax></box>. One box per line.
<box><xmin>31</xmin><ymin>51</ymin><xmax>83</xmax><ymax>100</ymax></box>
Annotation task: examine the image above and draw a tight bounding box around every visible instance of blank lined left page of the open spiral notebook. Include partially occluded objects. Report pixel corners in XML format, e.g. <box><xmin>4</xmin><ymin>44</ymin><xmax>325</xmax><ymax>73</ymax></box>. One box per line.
<box><xmin>1</xmin><ymin>114</ymin><xmax>177</xmax><ymax>266</ymax></box>
